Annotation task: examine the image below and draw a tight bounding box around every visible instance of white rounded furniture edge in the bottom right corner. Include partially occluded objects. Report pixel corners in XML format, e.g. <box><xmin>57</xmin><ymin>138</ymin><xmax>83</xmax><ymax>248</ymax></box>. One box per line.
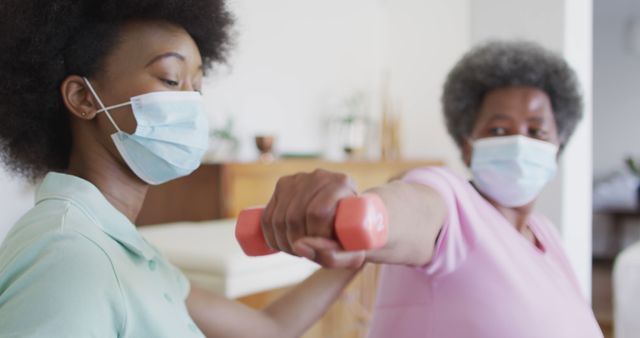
<box><xmin>613</xmin><ymin>242</ymin><xmax>640</xmax><ymax>338</ymax></box>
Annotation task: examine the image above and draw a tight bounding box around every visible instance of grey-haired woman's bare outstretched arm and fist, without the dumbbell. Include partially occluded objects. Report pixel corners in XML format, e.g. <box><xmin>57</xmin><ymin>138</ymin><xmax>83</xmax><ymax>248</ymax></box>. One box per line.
<box><xmin>261</xmin><ymin>170</ymin><xmax>447</xmax><ymax>267</ymax></box>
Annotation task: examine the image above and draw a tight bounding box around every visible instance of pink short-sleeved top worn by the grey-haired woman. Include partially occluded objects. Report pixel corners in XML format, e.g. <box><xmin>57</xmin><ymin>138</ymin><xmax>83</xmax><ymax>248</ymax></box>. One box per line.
<box><xmin>369</xmin><ymin>168</ymin><xmax>602</xmax><ymax>338</ymax></box>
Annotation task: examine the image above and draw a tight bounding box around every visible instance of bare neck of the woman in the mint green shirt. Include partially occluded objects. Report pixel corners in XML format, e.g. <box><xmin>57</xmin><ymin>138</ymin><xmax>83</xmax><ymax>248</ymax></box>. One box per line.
<box><xmin>67</xmin><ymin>139</ymin><xmax>149</xmax><ymax>223</ymax></box>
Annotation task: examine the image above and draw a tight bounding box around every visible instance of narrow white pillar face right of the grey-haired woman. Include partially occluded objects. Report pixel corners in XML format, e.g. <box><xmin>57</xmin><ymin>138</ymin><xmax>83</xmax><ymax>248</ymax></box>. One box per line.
<box><xmin>560</xmin><ymin>0</ymin><xmax>593</xmax><ymax>299</ymax></box>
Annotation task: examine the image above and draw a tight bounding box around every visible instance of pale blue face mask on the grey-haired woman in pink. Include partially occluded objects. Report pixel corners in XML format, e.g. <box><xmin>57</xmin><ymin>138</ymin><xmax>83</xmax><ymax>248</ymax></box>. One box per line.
<box><xmin>471</xmin><ymin>135</ymin><xmax>558</xmax><ymax>208</ymax></box>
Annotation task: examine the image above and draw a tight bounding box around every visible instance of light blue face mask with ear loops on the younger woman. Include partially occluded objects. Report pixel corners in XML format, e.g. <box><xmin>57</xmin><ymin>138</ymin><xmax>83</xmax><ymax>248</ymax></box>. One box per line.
<box><xmin>84</xmin><ymin>78</ymin><xmax>209</xmax><ymax>185</ymax></box>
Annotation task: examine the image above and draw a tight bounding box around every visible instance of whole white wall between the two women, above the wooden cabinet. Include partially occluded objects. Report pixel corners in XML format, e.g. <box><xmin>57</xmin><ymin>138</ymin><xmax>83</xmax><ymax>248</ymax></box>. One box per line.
<box><xmin>205</xmin><ymin>0</ymin><xmax>469</xmax><ymax>163</ymax></box>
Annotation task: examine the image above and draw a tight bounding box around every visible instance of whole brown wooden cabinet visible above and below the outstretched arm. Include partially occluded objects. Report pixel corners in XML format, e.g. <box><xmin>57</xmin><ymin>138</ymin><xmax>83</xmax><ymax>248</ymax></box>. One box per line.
<box><xmin>137</xmin><ymin>160</ymin><xmax>442</xmax><ymax>338</ymax></box>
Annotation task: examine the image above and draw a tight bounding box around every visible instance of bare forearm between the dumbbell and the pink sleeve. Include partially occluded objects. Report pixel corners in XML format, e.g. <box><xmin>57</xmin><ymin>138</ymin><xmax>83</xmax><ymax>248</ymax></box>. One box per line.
<box><xmin>366</xmin><ymin>181</ymin><xmax>447</xmax><ymax>266</ymax></box>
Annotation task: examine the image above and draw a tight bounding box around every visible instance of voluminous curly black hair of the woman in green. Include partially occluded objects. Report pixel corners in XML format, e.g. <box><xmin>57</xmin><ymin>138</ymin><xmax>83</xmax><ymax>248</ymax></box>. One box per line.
<box><xmin>0</xmin><ymin>0</ymin><xmax>233</xmax><ymax>180</ymax></box>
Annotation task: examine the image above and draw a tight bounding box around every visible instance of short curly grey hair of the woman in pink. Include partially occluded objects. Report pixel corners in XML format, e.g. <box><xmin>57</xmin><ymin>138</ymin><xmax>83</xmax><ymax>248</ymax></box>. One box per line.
<box><xmin>442</xmin><ymin>41</ymin><xmax>582</xmax><ymax>149</ymax></box>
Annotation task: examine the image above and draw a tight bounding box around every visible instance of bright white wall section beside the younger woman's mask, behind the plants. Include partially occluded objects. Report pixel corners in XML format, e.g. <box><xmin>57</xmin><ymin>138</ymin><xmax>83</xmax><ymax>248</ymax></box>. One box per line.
<box><xmin>205</xmin><ymin>0</ymin><xmax>387</xmax><ymax>160</ymax></box>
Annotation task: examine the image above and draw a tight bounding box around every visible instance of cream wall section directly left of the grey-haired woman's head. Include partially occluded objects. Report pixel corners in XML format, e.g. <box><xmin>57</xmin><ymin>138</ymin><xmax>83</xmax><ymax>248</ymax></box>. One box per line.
<box><xmin>388</xmin><ymin>0</ymin><xmax>471</xmax><ymax>173</ymax></box>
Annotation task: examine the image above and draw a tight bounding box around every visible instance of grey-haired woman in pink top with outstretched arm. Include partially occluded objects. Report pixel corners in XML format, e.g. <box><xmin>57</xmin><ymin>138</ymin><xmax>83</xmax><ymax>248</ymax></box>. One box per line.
<box><xmin>262</xmin><ymin>42</ymin><xmax>602</xmax><ymax>338</ymax></box>
